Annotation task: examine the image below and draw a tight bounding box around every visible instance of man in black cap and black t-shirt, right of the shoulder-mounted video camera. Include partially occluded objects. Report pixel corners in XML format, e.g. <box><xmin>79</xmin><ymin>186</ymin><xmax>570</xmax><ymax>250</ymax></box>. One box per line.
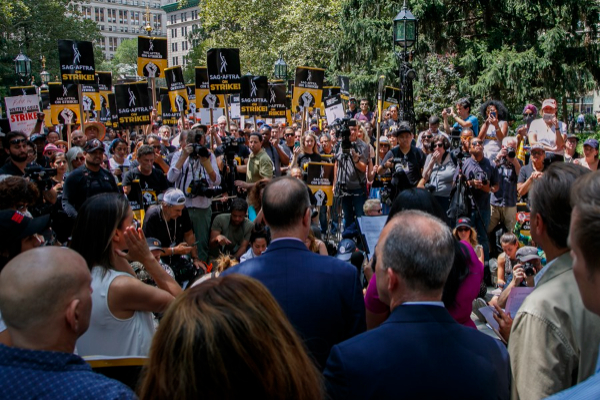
<box><xmin>378</xmin><ymin>121</ymin><xmax>425</xmax><ymax>198</ymax></box>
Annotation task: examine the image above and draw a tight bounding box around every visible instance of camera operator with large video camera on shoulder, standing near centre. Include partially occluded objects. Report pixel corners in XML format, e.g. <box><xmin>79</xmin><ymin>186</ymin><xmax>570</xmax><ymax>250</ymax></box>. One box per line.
<box><xmin>333</xmin><ymin>119</ymin><xmax>370</xmax><ymax>225</ymax></box>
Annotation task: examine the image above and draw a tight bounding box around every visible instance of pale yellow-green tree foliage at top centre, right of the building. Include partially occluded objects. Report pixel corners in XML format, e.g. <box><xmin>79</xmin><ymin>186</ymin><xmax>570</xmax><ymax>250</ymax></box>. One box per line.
<box><xmin>186</xmin><ymin>0</ymin><xmax>340</xmax><ymax>79</ymax></box>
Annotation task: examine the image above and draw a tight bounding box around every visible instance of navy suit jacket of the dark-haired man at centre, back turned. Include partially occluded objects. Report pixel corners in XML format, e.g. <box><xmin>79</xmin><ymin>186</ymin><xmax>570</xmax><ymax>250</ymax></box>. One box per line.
<box><xmin>221</xmin><ymin>239</ymin><xmax>366</xmax><ymax>369</ymax></box>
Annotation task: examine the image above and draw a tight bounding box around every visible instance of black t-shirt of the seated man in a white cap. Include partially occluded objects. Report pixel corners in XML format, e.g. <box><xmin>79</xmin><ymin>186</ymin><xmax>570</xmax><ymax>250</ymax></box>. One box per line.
<box><xmin>143</xmin><ymin>205</ymin><xmax>192</xmax><ymax>247</ymax></box>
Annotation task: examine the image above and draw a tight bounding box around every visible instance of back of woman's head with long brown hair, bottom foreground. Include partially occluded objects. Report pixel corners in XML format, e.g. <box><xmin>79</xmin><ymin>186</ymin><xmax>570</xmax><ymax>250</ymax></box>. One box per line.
<box><xmin>138</xmin><ymin>274</ymin><xmax>324</xmax><ymax>400</ymax></box>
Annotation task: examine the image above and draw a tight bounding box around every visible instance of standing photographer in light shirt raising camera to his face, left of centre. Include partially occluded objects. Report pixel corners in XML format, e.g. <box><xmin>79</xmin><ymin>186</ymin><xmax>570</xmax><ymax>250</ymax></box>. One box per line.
<box><xmin>167</xmin><ymin>130</ymin><xmax>221</xmax><ymax>261</ymax></box>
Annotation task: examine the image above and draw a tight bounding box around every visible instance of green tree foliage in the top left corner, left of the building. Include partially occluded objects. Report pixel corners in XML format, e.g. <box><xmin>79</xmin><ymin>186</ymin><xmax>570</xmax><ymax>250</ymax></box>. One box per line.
<box><xmin>0</xmin><ymin>0</ymin><xmax>103</xmax><ymax>94</ymax></box>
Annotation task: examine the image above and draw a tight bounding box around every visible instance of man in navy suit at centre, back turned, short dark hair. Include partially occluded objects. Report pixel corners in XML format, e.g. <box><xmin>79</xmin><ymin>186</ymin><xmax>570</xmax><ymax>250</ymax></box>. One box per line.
<box><xmin>222</xmin><ymin>177</ymin><xmax>366</xmax><ymax>369</ymax></box>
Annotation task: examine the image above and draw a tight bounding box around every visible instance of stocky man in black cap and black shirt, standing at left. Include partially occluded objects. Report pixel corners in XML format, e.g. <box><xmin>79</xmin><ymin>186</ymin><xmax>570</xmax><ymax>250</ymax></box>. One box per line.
<box><xmin>62</xmin><ymin>139</ymin><xmax>119</xmax><ymax>218</ymax></box>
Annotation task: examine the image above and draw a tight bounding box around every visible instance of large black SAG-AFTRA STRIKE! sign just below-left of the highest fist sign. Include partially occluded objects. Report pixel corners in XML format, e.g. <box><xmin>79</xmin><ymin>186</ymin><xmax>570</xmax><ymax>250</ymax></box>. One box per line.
<box><xmin>115</xmin><ymin>82</ymin><xmax>152</xmax><ymax>127</ymax></box>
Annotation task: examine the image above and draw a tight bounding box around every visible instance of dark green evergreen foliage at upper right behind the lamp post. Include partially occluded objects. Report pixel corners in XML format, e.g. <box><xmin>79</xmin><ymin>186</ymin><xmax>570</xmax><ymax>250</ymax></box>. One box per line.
<box><xmin>330</xmin><ymin>0</ymin><xmax>600</xmax><ymax>122</ymax></box>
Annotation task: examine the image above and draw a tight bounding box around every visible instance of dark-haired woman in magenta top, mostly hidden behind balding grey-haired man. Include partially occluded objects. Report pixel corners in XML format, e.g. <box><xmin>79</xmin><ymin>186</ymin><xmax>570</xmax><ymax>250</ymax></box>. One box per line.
<box><xmin>365</xmin><ymin>189</ymin><xmax>483</xmax><ymax>329</ymax></box>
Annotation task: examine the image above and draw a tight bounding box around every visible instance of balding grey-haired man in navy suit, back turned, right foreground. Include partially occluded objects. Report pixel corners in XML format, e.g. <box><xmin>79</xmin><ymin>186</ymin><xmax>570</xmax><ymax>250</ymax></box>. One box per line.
<box><xmin>324</xmin><ymin>211</ymin><xmax>510</xmax><ymax>399</ymax></box>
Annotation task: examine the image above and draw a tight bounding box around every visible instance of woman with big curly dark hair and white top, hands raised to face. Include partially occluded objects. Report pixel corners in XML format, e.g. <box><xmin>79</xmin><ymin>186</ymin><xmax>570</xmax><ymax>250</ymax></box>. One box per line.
<box><xmin>478</xmin><ymin>100</ymin><xmax>508</xmax><ymax>160</ymax></box>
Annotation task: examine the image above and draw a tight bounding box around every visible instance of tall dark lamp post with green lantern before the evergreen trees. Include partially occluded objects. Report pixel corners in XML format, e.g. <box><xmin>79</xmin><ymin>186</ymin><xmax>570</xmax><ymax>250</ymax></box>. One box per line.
<box><xmin>394</xmin><ymin>0</ymin><xmax>418</xmax><ymax>132</ymax></box>
